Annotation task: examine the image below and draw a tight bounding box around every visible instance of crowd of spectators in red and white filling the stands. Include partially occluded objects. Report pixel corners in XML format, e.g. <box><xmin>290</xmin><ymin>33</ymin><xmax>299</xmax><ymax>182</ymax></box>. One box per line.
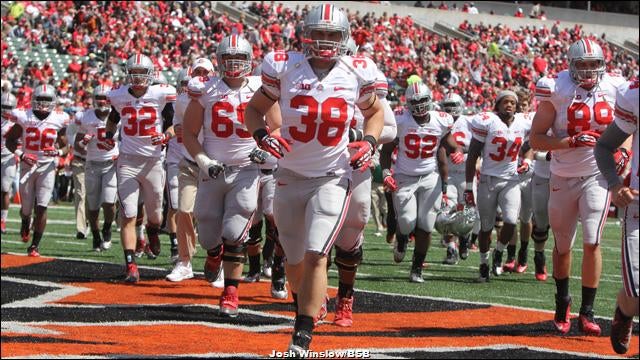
<box><xmin>2</xmin><ymin>1</ymin><xmax>638</xmax><ymax>115</ymax></box>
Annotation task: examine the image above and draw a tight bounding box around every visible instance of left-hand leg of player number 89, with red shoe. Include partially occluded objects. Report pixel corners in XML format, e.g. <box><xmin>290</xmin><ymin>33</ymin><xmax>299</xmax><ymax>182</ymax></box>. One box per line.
<box><xmin>549</xmin><ymin>175</ymin><xmax>581</xmax><ymax>334</ymax></box>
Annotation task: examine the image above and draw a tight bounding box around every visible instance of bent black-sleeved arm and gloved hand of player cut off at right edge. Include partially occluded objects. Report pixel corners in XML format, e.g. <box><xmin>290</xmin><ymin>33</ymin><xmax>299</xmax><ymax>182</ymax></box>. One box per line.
<box><xmin>593</xmin><ymin>122</ymin><xmax>639</xmax><ymax>207</ymax></box>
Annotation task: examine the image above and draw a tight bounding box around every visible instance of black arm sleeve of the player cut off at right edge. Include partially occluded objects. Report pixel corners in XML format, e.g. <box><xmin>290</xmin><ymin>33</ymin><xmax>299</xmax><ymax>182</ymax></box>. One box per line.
<box><xmin>593</xmin><ymin>123</ymin><xmax>629</xmax><ymax>189</ymax></box>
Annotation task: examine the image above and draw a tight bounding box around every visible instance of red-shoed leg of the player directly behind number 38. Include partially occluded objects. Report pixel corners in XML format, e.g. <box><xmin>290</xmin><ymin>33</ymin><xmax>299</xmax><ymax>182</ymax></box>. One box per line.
<box><xmin>334</xmin><ymin>171</ymin><xmax>371</xmax><ymax>327</ymax></box>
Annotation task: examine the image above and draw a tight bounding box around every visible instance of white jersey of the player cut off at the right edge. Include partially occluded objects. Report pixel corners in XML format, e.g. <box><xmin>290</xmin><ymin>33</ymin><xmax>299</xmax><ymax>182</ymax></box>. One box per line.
<box><xmin>615</xmin><ymin>80</ymin><xmax>640</xmax><ymax>190</ymax></box>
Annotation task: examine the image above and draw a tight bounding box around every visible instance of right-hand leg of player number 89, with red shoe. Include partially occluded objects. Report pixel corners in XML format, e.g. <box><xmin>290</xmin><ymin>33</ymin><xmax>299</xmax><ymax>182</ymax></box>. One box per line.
<box><xmin>578</xmin><ymin>174</ymin><xmax>610</xmax><ymax>336</ymax></box>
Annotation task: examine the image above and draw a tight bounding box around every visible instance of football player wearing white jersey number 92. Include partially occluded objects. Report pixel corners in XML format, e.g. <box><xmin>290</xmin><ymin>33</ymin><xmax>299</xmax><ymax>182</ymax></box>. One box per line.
<box><xmin>380</xmin><ymin>82</ymin><xmax>464</xmax><ymax>283</ymax></box>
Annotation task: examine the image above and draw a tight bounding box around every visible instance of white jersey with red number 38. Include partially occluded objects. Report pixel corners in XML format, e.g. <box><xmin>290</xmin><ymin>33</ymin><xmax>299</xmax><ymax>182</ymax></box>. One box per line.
<box><xmin>262</xmin><ymin>51</ymin><xmax>378</xmax><ymax>177</ymax></box>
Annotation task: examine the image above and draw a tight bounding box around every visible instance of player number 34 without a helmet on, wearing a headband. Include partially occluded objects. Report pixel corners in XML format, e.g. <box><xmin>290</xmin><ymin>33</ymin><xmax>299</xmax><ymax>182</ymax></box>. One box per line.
<box><xmin>464</xmin><ymin>90</ymin><xmax>532</xmax><ymax>282</ymax></box>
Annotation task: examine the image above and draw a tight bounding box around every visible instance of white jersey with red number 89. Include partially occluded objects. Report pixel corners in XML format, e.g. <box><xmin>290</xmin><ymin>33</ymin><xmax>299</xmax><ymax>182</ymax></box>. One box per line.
<box><xmin>536</xmin><ymin>70</ymin><xmax>624</xmax><ymax>177</ymax></box>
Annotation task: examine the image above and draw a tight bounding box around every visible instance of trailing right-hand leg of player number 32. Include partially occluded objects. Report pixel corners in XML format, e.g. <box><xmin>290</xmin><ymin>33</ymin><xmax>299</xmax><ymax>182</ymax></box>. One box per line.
<box><xmin>138</xmin><ymin>158</ymin><xmax>165</xmax><ymax>257</ymax></box>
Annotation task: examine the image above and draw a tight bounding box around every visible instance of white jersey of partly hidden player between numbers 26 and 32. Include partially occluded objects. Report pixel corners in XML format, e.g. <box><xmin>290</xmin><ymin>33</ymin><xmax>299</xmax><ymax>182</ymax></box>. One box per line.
<box><xmin>77</xmin><ymin>109</ymin><xmax>120</xmax><ymax>161</ymax></box>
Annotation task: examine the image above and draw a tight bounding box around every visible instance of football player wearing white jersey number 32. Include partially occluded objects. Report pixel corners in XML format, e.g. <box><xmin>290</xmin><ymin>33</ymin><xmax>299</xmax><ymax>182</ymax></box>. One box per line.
<box><xmin>106</xmin><ymin>54</ymin><xmax>176</xmax><ymax>283</ymax></box>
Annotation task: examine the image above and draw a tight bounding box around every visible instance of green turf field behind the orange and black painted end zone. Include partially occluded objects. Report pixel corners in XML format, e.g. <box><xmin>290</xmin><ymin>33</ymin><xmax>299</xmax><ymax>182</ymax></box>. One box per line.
<box><xmin>2</xmin><ymin>205</ymin><xmax>622</xmax><ymax>317</ymax></box>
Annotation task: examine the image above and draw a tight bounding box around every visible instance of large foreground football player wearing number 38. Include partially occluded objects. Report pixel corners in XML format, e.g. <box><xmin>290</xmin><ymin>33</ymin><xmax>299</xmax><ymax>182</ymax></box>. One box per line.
<box><xmin>246</xmin><ymin>4</ymin><xmax>384</xmax><ymax>354</ymax></box>
